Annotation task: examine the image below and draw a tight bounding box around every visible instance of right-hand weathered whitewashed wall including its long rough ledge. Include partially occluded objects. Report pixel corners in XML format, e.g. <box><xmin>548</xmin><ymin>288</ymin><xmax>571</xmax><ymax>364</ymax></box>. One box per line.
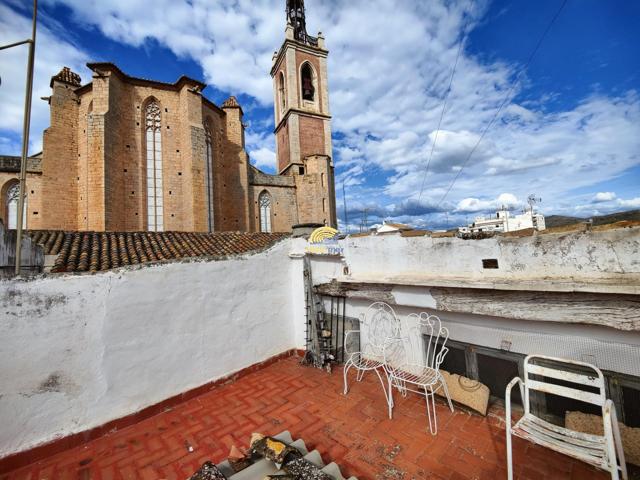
<box><xmin>302</xmin><ymin>228</ymin><xmax>640</xmax><ymax>376</ymax></box>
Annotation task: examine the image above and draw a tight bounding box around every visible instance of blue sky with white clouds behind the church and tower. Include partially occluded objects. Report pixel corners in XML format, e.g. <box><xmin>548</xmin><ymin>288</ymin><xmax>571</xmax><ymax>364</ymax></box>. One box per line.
<box><xmin>0</xmin><ymin>0</ymin><xmax>640</xmax><ymax>230</ymax></box>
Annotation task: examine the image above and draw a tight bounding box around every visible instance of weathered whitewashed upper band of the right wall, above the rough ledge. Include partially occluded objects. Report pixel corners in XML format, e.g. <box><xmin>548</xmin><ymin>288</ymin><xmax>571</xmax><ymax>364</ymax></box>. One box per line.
<box><xmin>315</xmin><ymin>227</ymin><xmax>640</xmax><ymax>294</ymax></box>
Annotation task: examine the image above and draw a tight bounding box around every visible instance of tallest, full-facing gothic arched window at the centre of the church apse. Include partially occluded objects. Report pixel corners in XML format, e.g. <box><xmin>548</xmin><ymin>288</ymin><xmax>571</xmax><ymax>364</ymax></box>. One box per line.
<box><xmin>145</xmin><ymin>100</ymin><xmax>164</xmax><ymax>232</ymax></box>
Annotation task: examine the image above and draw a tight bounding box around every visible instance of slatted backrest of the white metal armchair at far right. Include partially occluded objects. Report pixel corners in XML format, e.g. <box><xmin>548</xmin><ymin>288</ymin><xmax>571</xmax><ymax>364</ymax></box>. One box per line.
<box><xmin>524</xmin><ymin>355</ymin><xmax>607</xmax><ymax>413</ymax></box>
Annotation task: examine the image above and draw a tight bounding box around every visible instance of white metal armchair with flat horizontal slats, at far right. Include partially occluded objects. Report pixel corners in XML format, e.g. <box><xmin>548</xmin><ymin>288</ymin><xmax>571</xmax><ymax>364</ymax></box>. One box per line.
<box><xmin>505</xmin><ymin>355</ymin><xmax>627</xmax><ymax>480</ymax></box>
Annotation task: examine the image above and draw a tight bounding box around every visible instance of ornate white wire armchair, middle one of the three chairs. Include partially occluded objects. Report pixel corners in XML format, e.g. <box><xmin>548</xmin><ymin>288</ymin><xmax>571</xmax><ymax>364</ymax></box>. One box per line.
<box><xmin>385</xmin><ymin>313</ymin><xmax>453</xmax><ymax>435</ymax></box>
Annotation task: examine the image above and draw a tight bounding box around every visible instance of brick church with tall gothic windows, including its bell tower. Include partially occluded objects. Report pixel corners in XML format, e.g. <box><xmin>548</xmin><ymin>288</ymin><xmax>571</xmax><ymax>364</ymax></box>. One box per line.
<box><xmin>0</xmin><ymin>0</ymin><xmax>336</xmax><ymax>232</ymax></box>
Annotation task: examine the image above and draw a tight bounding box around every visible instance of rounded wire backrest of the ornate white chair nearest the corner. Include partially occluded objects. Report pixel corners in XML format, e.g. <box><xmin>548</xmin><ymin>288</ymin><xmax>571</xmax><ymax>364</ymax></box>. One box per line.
<box><xmin>360</xmin><ymin>302</ymin><xmax>400</xmax><ymax>357</ymax></box>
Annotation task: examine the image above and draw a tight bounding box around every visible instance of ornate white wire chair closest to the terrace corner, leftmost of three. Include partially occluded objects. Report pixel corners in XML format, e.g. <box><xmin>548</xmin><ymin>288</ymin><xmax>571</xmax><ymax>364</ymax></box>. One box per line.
<box><xmin>344</xmin><ymin>302</ymin><xmax>400</xmax><ymax>403</ymax></box>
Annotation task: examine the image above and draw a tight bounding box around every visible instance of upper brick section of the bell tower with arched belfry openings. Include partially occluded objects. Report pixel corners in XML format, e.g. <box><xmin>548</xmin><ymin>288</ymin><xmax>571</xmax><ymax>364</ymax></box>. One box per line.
<box><xmin>271</xmin><ymin>0</ymin><xmax>332</xmax><ymax>175</ymax></box>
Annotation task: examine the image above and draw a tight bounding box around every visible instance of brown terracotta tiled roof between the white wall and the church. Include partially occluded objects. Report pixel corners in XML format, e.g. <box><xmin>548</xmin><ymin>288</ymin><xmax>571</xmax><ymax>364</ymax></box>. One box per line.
<box><xmin>28</xmin><ymin>230</ymin><xmax>288</xmax><ymax>272</ymax></box>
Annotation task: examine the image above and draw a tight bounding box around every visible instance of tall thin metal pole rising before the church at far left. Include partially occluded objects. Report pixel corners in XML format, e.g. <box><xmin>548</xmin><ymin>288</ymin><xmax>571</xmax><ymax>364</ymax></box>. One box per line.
<box><xmin>16</xmin><ymin>0</ymin><xmax>38</xmax><ymax>275</ymax></box>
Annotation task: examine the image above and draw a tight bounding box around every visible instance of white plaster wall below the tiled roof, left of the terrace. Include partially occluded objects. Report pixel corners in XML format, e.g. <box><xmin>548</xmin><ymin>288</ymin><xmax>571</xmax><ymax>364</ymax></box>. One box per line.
<box><xmin>0</xmin><ymin>241</ymin><xmax>296</xmax><ymax>457</ymax></box>
